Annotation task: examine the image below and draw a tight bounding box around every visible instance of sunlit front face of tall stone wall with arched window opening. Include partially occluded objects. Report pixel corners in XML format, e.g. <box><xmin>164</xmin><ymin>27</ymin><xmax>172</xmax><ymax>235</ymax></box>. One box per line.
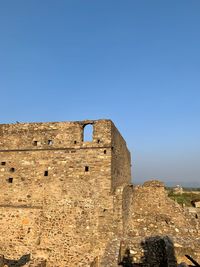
<box><xmin>0</xmin><ymin>120</ymin><xmax>130</xmax><ymax>267</ymax></box>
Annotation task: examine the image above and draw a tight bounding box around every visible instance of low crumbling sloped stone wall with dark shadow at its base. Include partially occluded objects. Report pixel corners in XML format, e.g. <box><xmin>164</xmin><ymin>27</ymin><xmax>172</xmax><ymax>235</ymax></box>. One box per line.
<box><xmin>125</xmin><ymin>181</ymin><xmax>200</xmax><ymax>266</ymax></box>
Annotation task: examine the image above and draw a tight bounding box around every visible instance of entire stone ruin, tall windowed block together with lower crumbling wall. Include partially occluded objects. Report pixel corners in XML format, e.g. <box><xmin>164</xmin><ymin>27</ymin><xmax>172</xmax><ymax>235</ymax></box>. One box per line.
<box><xmin>0</xmin><ymin>120</ymin><xmax>200</xmax><ymax>267</ymax></box>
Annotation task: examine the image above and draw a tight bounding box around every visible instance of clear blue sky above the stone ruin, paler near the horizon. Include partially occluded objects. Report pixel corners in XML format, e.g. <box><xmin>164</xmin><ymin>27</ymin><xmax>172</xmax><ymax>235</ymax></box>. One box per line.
<box><xmin>0</xmin><ymin>0</ymin><xmax>200</xmax><ymax>185</ymax></box>
